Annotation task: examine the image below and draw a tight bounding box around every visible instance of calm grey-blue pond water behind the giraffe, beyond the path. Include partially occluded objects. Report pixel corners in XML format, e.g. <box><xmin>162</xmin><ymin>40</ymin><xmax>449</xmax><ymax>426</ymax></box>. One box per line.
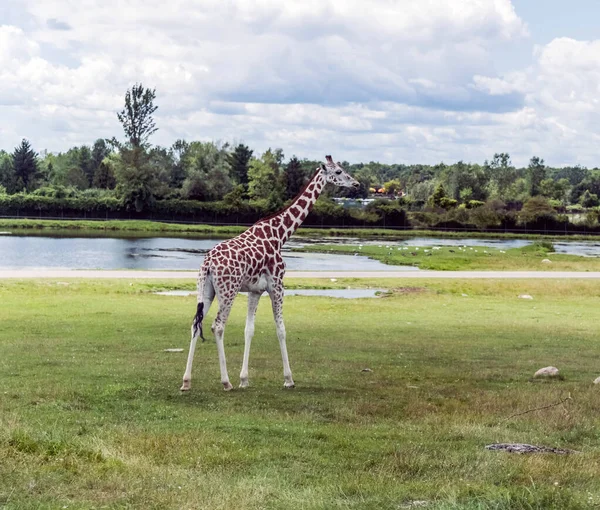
<box><xmin>0</xmin><ymin>233</ymin><xmax>600</xmax><ymax>271</ymax></box>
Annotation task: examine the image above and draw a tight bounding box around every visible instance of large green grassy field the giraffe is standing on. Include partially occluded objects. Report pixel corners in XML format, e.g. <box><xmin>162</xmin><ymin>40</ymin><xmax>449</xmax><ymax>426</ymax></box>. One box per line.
<box><xmin>0</xmin><ymin>279</ymin><xmax>600</xmax><ymax>510</ymax></box>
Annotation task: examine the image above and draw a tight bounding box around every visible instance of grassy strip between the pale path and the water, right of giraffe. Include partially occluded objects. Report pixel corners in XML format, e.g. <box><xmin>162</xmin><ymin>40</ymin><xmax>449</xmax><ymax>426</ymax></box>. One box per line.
<box><xmin>295</xmin><ymin>241</ymin><xmax>600</xmax><ymax>271</ymax></box>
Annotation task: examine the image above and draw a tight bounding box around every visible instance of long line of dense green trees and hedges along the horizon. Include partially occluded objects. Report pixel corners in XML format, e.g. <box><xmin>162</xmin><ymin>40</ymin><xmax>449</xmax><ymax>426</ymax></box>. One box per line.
<box><xmin>0</xmin><ymin>84</ymin><xmax>600</xmax><ymax>228</ymax></box>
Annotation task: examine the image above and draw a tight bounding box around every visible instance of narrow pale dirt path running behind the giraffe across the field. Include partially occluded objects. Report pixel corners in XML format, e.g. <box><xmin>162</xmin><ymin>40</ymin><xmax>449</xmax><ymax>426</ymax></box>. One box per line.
<box><xmin>0</xmin><ymin>269</ymin><xmax>600</xmax><ymax>280</ymax></box>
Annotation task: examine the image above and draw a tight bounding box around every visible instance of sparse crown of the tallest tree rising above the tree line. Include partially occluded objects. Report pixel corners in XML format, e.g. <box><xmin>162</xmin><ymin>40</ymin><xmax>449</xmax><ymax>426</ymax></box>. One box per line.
<box><xmin>117</xmin><ymin>83</ymin><xmax>158</xmax><ymax>148</ymax></box>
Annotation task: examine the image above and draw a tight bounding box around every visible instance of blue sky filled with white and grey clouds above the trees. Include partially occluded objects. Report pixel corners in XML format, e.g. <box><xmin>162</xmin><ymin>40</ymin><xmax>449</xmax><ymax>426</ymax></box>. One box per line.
<box><xmin>0</xmin><ymin>0</ymin><xmax>600</xmax><ymax>167</ymax></box>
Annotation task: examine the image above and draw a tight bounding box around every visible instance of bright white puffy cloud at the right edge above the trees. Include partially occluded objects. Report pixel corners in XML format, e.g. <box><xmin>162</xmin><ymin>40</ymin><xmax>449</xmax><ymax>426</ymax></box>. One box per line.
<box><xmin>475</xmin><ymin>38</ymin><xmax>600</xmax><ymax>166</ymax></box>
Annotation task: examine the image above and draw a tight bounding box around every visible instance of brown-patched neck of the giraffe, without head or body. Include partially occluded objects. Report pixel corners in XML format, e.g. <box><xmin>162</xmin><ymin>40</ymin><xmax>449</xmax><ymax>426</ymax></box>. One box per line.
<box><xmin>259</xmin><ymin>170</ymin><xmax>326</xmax><ymax>246</ymax></box>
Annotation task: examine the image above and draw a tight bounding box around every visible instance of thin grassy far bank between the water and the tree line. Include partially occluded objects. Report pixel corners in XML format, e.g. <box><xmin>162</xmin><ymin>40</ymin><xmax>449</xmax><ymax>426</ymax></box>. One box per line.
<box><xmin>0</xmin><ymin>218</ymin><xmax>600</xmax><ymax>241</ymax></box>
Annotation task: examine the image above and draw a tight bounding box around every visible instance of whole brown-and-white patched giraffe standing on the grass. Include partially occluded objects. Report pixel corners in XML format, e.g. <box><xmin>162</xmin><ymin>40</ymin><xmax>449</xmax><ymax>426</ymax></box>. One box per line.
<box><xmin>181</xmin><ymin>156</ymin><xmax>359</xmax><ymax>391</ymax></box>
